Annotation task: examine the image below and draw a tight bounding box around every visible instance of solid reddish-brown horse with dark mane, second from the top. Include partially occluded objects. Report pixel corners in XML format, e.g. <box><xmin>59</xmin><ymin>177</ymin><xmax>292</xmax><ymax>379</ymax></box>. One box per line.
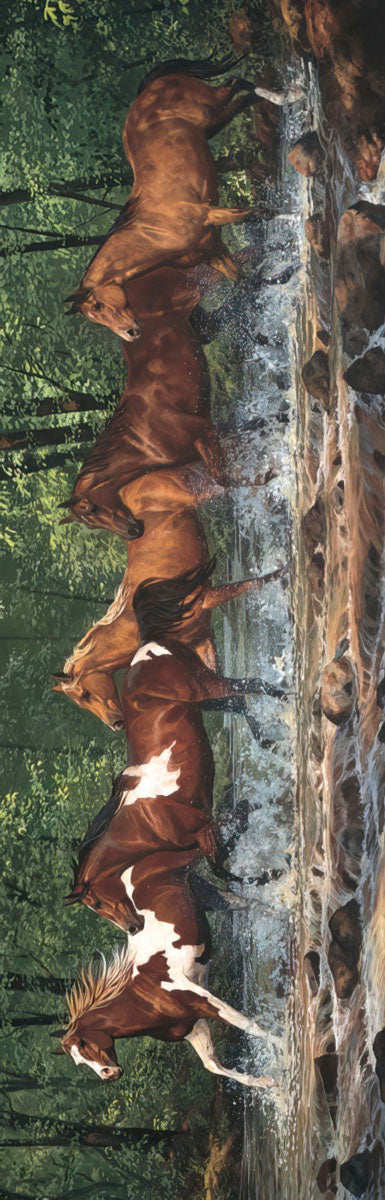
<box><xmin>56</xmin><ymin>313</ymin><xmax>219</xmax><ymax>539</ymax></box>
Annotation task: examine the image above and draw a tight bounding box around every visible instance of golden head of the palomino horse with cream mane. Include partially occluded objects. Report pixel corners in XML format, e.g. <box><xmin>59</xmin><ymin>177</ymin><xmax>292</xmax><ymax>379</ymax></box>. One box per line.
<box><xmin>53</xmin><ymin>667</ymin><xmax>124</xmax><ymax>733</ymax></box>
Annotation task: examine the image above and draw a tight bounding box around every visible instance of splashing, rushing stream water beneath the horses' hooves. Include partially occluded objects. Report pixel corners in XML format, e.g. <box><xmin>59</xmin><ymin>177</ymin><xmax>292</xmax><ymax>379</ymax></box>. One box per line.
<box><xmin>203</xmin><ymin>51</ymin><xmax>385</xmax><ymax>1200</ymax></box>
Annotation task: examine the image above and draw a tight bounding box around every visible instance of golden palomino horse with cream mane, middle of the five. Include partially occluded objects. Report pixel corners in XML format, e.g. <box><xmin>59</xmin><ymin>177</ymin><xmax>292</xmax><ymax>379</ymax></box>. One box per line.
<box><xmin>53</xmin><ymin>525</ymin><xmax>283</xmax><ymax>732</ymax></box>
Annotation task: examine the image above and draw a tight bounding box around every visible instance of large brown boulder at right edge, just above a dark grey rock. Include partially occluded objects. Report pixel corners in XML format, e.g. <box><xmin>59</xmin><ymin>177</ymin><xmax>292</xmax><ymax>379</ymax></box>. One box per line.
<box><xmin>335</xmin><ymin>200</ymin><xmax>385</xmax><ymax>355</ymax></box>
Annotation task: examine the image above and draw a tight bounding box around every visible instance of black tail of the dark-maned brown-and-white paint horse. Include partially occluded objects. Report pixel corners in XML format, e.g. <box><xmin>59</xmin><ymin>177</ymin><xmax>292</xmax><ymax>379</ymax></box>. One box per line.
<box><xmin>133</xmin><ymin>558</ymin><xmax>216</xmax><ymax>643</ymax></box>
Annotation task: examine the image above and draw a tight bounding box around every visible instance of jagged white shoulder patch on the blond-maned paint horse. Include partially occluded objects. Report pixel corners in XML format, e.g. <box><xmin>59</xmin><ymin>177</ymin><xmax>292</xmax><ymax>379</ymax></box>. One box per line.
<box><xmin>121</xmin><ymin>866</ymin><xmax>203</xmax><ymax>990</ymax></box>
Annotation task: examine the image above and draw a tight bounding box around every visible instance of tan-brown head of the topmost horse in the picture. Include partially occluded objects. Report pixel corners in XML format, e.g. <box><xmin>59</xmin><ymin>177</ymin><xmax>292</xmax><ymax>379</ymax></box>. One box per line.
<box><xmin>65</xmin><ymin>282</ymin><xmax>142</xmax><ymax>342</ymax></box>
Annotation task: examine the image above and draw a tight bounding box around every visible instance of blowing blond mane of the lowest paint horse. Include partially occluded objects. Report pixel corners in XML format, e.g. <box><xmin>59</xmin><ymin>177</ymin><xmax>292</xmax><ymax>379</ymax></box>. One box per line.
<box><xmin>66</xmin><ymin>941</ymin><xmax>136</xmax><ymax>1037</ymax></box>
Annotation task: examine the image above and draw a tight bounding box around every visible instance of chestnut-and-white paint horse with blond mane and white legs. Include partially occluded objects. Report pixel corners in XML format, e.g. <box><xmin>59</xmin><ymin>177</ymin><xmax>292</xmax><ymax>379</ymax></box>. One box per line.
<box><xmin>56</xmin><ymin>926</ymin><xmax>276</xmax><ymax>1087</ymax></box>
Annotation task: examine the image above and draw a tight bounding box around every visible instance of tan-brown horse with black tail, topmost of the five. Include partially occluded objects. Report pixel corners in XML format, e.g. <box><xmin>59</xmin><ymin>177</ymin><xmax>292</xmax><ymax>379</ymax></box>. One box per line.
<box><xmin>63</xmin><ymin>59</ymin><xmax>261</xmax><ymax>341</ymax></box>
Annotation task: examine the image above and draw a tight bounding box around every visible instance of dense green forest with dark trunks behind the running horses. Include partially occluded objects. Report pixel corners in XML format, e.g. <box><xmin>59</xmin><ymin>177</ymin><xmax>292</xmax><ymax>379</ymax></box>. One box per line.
<box><xmin>0</xmin><ymin>0</ymin><xmax>281</xmax><ymax>1200</ymax></box>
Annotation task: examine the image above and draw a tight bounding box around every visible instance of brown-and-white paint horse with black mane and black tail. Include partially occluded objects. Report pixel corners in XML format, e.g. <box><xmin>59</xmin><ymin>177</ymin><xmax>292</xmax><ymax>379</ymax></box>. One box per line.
<box><xmin>62</xmin><ymin>568</ymin><xmax>284</xmax><ymax>931</ymax></box>
